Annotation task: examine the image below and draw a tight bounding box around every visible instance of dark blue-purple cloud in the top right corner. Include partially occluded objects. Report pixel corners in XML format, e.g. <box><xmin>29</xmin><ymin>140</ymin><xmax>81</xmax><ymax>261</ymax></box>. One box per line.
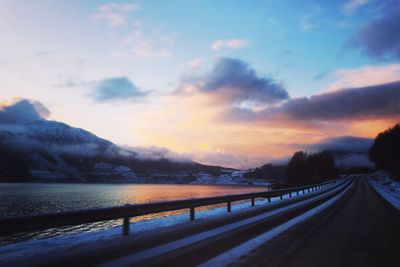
<box><xmin>349</xmin><ymin>1</ymin><xmax>400</xmax><ymax>59</ymax></box>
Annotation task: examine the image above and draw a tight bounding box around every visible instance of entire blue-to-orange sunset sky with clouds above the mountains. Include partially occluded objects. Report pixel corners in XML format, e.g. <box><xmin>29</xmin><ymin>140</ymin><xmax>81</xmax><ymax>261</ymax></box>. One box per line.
<box><xmin>0</xmin><ymin>0</ymin><xmax>400</xmax><ymax>168</ymax></box>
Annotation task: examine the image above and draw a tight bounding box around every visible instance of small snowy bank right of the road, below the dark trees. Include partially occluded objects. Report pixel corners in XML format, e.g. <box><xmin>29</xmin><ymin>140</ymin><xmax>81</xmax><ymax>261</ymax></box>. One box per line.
<box><xmin>368</xmin><ymin>171</ymin><xmax>400</xmax><ymax>210</ymax></box>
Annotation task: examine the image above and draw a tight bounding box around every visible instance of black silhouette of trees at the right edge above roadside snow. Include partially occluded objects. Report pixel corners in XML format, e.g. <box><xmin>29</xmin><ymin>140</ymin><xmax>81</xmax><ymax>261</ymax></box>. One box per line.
<box><xmin>369</xmin><ymin>124</ymin><xmax>400</xmax><ymax>180</ymax></box>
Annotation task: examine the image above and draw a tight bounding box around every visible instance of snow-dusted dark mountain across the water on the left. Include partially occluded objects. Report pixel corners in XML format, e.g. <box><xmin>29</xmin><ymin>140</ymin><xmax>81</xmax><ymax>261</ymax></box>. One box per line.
<box><xmin>0</xmin><ymin>120</ymin><xmax>234</xmax><ymax>183</ymax></box>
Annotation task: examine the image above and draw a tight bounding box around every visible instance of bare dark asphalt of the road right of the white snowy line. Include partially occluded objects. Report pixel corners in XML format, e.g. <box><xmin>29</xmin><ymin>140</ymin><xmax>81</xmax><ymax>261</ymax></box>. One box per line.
<box><xmin>232</xmin><ymin>176</ymin><xmax>400</xmax><ymax>267</ymax></box>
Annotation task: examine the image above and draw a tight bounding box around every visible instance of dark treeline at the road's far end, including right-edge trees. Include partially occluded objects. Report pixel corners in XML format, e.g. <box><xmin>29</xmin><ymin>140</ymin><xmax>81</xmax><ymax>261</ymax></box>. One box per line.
<box><xmin>245</xmin><ymin>124</ymin><xmax>400</xmax><ymax>187</ymax></box>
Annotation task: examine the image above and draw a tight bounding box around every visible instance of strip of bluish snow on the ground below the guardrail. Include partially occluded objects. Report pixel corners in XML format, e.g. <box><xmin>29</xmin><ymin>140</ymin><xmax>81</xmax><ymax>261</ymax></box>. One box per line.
<box><xmin>0</xmin><ymin>181</ymin><xmax>340</xmax><ymax>265</ymax></box>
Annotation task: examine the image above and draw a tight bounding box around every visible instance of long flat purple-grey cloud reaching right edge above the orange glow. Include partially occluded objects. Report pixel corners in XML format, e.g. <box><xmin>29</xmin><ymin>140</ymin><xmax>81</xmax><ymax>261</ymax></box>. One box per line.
<box><xmin>279</xmin><ymin>82</ymin><xmax>400</xmax><ymax>120</ymax></box>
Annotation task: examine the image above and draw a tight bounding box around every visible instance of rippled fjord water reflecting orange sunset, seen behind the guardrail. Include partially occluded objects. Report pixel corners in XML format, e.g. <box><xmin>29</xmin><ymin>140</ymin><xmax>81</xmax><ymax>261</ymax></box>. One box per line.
<box><xmin>0</xmin><ymin>183</ymin><xmax>267</xmax><ymax>243</ymax></box>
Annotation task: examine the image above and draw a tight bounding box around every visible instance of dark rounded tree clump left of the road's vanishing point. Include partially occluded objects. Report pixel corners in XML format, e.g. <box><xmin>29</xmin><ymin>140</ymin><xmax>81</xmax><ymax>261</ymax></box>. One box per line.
<box><xmin>287</xmin><ymin>151</ymin><xmax>337</xmax><ymax>186</ymax></box>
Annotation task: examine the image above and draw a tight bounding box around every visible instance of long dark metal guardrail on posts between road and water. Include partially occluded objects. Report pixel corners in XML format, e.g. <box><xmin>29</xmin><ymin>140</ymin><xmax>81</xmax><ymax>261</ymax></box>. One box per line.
<box><xmin>0</xmin><ymin>181</ymin><xmax>334</xmax><ymax>235</ymax></box>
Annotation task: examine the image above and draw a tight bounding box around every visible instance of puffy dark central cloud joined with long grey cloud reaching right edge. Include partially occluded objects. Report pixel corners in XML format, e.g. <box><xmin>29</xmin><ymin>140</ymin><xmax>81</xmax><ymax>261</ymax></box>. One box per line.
<box><xmin>178</xmin><ymin>58</ymin><xmax>400</xmax><ymax>124</ymax></box>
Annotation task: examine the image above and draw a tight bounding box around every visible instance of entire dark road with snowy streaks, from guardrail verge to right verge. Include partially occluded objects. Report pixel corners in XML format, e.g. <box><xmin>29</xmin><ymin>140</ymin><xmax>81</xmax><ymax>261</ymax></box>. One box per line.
<box><xmin>13</xmin><ymin>175</ymin><xmax>400</xmax><ymax>267</ymax></box>
